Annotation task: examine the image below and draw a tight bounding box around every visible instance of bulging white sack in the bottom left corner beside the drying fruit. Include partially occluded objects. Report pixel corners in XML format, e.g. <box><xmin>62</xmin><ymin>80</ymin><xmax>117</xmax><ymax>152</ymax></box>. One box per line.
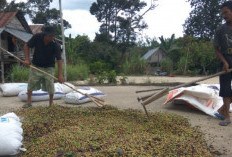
<box><xmin>0</xmin><ymin>113</ymin><xmax>23</xmax><ymax>156</ymax></box>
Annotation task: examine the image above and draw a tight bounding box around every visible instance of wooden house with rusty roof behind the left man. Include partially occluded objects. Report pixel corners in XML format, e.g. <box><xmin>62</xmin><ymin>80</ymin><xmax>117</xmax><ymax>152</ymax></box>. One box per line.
<box><xmin>0</xmin><ymin>11</ymin><xmax>32</xmax><ymax>82</ymax></box>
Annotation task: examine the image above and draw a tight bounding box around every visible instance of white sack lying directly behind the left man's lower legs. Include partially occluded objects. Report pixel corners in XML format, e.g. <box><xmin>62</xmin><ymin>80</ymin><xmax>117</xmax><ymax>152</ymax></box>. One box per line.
<box><xmin>18</xmin><ymin>90</ymin><xmax>65</xmax><ymax>102</ymax></box>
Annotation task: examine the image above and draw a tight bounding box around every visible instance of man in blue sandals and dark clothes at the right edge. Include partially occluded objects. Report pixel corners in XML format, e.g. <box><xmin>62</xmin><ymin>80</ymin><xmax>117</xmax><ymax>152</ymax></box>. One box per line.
<box><xmin>214</xmin><ymin>1</ymin><xmax>232</xmax><ymax>126</ymax></box>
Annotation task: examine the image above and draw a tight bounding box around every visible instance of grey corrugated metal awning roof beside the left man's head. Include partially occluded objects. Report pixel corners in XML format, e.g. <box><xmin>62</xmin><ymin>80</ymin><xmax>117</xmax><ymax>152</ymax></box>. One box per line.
<box><xmin>4</xmin><ymin>28</ymin><xmax>32</xmax><ymax>42</ymax></box>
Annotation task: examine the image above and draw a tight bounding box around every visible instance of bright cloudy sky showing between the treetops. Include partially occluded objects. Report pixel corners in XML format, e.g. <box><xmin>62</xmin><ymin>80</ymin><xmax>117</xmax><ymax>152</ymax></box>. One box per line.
<box><xmin>10</xmin><ymin>0</ymin><xmax>191</xmax><ymax>40</ymax></box>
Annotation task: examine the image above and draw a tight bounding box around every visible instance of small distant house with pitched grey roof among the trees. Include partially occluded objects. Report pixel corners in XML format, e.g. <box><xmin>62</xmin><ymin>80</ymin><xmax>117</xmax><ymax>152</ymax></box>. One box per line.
<box><xmin>141</xmin><ymin>47</ymin><xmax>167</xmax><ymax>74</ymax></box>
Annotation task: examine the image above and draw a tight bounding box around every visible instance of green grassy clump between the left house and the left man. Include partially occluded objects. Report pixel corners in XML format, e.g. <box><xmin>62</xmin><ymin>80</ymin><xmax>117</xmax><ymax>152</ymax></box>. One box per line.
<box><xmin>7</xmin><ymin>64</ymin><xmax>29</xmax><ymax>82</ymax></box>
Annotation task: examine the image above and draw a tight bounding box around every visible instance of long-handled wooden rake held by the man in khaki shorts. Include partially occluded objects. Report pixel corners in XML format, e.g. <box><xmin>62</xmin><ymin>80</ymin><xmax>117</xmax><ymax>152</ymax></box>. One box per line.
<box><xmin>0</xmin><ymin>47</ymin><xmax>105</xmax><ymax>107</ymax></box>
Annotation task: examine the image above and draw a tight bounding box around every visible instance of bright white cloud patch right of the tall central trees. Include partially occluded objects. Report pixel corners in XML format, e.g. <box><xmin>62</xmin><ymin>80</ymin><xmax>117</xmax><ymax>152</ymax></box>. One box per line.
<box><xmin>143</xmin><ymin>0</ymin><xmax>191</xmax><ymax>38</ymax></box>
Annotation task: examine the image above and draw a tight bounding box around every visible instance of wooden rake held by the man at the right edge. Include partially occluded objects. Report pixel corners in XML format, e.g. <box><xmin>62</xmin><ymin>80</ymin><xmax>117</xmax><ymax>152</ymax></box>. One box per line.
<box><xmin>137</xmin><ymin>69</ymin><xmax>232</xmax><ymax>118</ymax></box>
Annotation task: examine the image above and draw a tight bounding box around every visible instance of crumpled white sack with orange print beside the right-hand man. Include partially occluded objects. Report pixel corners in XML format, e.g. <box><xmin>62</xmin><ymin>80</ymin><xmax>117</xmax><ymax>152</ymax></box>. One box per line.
<box><xmin>165</xmin><ymin>84</ymin><xmax>232</xmax><ymax>117</ymax></box>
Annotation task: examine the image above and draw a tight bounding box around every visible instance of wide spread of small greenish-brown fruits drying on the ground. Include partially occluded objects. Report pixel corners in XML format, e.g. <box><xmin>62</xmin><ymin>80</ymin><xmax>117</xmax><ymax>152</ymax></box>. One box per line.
<box><xmin>16</xmin><ymin>106</ymin><xmax>212</xmax><ymax>157</ymax></box>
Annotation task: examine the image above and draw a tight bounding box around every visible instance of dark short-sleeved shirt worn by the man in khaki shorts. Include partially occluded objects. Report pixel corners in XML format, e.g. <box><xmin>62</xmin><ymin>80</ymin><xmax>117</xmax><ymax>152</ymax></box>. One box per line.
<box><xmin>27</xmin><ymin>33</ymin><xmax>61</xmax><ymax>68</ymax></box>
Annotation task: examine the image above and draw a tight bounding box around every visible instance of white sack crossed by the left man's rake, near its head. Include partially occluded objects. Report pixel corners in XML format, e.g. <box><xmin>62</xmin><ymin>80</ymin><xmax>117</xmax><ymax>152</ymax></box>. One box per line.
<box><xmin>64</xmin><ymin>87</ymin><xmax>105</xmax><ymax>104</ymax></box>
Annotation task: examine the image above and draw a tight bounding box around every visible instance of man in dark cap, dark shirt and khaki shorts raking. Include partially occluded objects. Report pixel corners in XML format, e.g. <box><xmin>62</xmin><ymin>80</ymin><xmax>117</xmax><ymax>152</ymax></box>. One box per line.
<box><xmin>23</xmin><ymin>26</ymin><xmax>64</xmax><ymax>108</ymax></box>
